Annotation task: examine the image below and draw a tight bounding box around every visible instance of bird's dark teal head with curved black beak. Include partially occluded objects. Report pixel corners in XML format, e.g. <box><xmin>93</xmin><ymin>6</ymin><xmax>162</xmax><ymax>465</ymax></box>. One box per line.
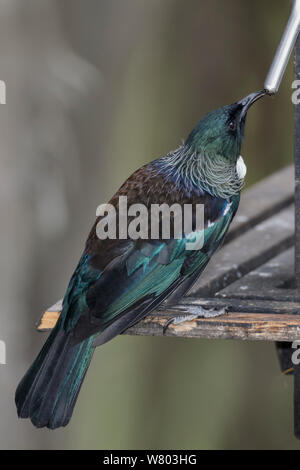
<box><xmin>186</xmin><ymin>91</ymin><xmax>266</xmax><ymax>164</ymax></box>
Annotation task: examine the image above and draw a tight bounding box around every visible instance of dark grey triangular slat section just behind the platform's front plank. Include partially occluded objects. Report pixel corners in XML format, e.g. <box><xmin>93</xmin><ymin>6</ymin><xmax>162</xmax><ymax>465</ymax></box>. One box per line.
<box><xmin>216</xmin><ymin>248</ymin><xmax>300</xmax><ymax>301</ymax></box>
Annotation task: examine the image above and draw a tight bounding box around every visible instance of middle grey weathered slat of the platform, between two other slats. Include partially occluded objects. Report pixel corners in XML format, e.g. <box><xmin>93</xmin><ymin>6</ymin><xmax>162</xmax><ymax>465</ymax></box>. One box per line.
<box><xmin>188</xmin><ymin>206</ymin><xmax>294</xmax><ymax>297</ymax></box>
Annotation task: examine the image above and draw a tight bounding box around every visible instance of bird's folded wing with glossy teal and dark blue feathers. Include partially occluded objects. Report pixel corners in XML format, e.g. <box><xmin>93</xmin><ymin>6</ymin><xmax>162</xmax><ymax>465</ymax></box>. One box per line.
<box><xmin>62</xmin><ymin>167</ymin><xmax>238</xmax><ymax>343</ymax></box>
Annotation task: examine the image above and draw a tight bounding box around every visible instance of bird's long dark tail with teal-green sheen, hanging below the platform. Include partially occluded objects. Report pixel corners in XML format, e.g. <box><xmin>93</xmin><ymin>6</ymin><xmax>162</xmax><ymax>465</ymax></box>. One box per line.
<box><xmin>15</xmin><ymin>325</ymin><xmax>94</xmax><ymax>429</ymax></box>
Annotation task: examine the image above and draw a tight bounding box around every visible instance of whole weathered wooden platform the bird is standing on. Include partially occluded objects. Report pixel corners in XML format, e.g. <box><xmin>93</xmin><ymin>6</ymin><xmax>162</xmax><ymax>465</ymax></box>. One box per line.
<box><xmin>37</xmin><ymin>163</ymin><xmax>300</xmax><ymax>342</ymax></box>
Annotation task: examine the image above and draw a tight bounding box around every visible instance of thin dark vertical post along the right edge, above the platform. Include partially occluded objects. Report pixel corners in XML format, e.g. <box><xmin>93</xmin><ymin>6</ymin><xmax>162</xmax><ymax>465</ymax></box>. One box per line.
<box><xmin>294</xmin><ymin>37</ymin><xmax>300</xmax><ymax>289</ymax></box>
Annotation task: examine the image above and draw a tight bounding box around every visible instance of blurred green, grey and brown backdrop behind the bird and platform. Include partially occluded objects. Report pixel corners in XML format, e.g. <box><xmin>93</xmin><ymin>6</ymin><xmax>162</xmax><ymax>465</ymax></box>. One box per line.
<box><xmin>0</xmin><ymin>0</ymin><xmax>300</xmax><ymax>449</ymax></box>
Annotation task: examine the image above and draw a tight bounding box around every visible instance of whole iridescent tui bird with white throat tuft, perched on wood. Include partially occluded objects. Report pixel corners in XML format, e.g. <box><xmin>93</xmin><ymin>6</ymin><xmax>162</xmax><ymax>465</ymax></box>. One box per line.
<box><xmin>15</xmin><ymin>91</ymin><xmax>266</xmax><ymax>429</ymax></box>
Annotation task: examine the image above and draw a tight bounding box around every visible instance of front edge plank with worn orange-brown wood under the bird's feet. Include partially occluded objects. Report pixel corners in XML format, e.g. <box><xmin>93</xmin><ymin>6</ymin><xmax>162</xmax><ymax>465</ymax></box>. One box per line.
<box><xmin>37</xmin><ymin>297</ymin><xmax>300</xmax><ymax>341</ymax></box>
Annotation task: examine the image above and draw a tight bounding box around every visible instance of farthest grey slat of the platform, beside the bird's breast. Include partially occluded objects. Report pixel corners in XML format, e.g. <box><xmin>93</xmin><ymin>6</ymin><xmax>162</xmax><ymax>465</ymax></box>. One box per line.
<box><xmin>226</xmin><ymin>165</ymin><xmax>294</xmax><ymax>243</ymax></box>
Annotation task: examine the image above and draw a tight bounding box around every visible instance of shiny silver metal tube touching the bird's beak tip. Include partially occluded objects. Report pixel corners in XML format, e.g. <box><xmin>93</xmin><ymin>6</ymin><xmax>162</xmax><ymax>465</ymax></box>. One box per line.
<box><xmin>265</xmin><ymin>0</ymin><xmax>300</xmax><ymax>94</ymax></box>
